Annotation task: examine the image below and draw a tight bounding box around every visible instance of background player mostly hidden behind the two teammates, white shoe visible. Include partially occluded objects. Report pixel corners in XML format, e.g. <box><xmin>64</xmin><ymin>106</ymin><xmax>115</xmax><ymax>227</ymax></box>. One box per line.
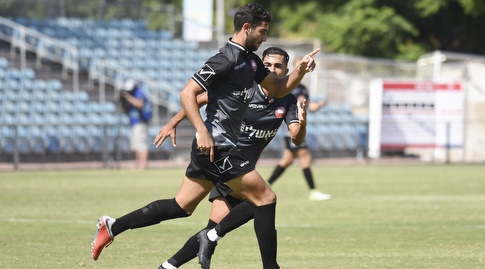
<box><xmin>268</xmin><ymin>59</ymin><xmax>331</xmax><ymax>201</ymax></box>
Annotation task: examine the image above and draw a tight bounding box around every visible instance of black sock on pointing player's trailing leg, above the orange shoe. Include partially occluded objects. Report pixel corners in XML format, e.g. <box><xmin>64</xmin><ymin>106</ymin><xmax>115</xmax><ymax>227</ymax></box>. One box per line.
<box><xmin>111</xmin><ymin>198</ymin><xmax>189</xmax><ymax>236</ymax></box>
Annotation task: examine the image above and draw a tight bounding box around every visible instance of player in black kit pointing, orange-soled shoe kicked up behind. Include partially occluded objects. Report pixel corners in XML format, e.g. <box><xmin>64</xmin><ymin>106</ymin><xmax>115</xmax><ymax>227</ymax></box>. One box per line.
<box><xmin>92</xmin><ymin>3</ymin><xmax>319</xmax><ymax>269</ymax></box>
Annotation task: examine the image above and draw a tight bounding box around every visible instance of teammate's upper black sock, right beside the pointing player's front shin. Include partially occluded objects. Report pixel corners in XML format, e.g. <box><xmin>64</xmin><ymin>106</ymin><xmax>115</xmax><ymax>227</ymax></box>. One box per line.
<box><xmin>214</xmin><ymin>202</ymin><xmax>256</xmax><ymax>237</ymax></box>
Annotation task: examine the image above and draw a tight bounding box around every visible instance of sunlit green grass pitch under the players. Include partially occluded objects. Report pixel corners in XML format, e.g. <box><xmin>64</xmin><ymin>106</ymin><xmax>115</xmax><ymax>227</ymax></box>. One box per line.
<box><xmin>0</xmin><ymin>162</ymin><xmax>485</xmax><ymax>269</ymax></box>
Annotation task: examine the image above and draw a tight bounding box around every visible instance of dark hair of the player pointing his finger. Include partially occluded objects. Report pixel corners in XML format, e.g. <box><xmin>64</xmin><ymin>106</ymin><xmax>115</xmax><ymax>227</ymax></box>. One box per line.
<box><xmin>234</xmin><ymin>3</ymin><xmax>273</xmax><ymax>33</ymax></box>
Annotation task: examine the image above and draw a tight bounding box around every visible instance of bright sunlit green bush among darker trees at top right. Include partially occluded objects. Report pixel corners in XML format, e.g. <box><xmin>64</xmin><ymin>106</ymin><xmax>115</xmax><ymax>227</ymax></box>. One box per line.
<box><xmin>320</xmin><ymin>1</ymin><xmax>418</xmax><ymax>58</ymax></box>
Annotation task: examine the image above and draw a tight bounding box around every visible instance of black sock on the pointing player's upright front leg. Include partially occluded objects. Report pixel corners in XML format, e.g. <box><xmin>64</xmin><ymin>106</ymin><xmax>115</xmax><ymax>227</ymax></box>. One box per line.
<box><xmin>254</xmin><ymin>203</ymin><xmax>280</xmax><ymax>269</ymax></box>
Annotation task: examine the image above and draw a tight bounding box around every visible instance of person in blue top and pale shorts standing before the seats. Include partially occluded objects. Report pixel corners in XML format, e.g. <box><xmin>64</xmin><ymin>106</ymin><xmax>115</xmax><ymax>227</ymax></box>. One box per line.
<box><xmin>121</xmin><ymin>79</ymin><xmax>152</xmax><ymax>170</ymax></box>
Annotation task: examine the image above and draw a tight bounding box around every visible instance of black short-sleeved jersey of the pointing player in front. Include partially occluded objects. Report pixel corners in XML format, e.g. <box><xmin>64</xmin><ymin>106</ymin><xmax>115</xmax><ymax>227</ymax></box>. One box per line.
<box><xmin>192</xmin><ymin>39</ymin><xmax>269</xmax><ymax>146</ymax></box>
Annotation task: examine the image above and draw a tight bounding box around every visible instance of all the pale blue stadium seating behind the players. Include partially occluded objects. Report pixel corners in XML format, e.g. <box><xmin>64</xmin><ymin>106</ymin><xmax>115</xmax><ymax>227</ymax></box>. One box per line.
<box><xmin>0</xmin><ymin>18</ymin><xmax>367</xmax><ymax>163</ymax></box>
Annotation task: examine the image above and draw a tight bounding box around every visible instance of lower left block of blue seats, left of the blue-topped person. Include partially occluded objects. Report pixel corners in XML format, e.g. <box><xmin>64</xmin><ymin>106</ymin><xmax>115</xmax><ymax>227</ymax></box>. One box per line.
<box><xmin>0</xmin><ymin>55</ymin><xmax>135</xmax><ymax>159</ymax></box>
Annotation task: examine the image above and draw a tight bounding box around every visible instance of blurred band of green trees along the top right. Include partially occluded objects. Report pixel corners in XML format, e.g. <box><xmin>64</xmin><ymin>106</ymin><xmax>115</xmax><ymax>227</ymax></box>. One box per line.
<box><xmin>261</xmin><ymin>0</ymin><xmax>485</xmax><ymax>60</ymax></box>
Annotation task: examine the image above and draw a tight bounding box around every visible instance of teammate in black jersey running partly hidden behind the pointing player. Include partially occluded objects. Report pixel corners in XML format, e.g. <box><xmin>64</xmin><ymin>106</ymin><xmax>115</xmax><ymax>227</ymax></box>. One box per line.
<box><xmin>155</xmin><ymin>47</ymin><xmax>306</xmax><ymax>269</ymax></box>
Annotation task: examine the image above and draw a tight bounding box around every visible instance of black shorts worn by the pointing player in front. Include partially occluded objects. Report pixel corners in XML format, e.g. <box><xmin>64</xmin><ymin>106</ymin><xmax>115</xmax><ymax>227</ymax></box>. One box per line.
<box><xmin>185</xmin><ymin>138</ymin><xmax>256</xmax><ymax>185</ymax></box>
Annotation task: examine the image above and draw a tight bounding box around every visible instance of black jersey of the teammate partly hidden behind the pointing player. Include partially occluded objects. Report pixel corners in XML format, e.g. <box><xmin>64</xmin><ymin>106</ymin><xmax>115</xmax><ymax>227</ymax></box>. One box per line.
<box><xmin>237</xmin><ymin>84</ymin><xmax>299</xmax><ymax>163</ymax></box>
